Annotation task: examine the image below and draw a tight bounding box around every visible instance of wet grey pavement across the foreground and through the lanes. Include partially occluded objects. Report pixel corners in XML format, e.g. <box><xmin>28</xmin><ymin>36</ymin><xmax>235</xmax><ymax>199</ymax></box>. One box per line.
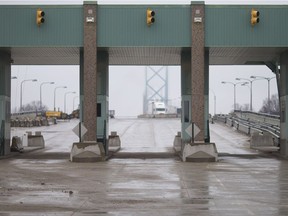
<box><xmin>0</xmin><ymin>119</ymin><xmax>288</xmax><ymax>216</ymax></box>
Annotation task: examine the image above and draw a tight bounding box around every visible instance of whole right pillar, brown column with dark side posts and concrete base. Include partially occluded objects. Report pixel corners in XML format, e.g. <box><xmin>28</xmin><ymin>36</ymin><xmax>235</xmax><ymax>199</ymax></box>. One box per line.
<box><xmin>181</xmin><ymin>2</ymin><xmax>218</xmax><ymax>162</ymax></box>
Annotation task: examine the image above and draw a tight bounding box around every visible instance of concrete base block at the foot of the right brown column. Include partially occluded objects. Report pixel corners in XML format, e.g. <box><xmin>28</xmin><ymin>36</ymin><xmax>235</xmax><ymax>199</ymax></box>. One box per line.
<box><xmin>182</xmin><ymin>143</ymin><xmax>218</xmax><ymax>162</ymax></box>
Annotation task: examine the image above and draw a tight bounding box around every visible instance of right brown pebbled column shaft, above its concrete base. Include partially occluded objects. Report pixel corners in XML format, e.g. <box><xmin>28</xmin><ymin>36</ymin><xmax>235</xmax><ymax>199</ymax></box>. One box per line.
<box><xmin>191</xmin><ymin>2</ymin><xmax>205</xmax><ymax>142</ymax></box>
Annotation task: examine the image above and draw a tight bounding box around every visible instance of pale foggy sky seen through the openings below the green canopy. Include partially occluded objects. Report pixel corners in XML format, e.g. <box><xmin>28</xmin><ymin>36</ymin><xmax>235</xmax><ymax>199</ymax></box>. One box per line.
<box><xmin>11</xmin><ymin>66</ymin><xmax>277</xmax><ymax>116</ymax></box>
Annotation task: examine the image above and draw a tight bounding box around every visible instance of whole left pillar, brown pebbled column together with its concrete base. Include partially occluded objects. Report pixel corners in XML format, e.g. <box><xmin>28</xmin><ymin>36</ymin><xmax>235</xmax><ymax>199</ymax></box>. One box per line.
<box><xmin>70</xmin><ymin>2</ymin><xmax>105</xmax><ymax>162</ymax></box>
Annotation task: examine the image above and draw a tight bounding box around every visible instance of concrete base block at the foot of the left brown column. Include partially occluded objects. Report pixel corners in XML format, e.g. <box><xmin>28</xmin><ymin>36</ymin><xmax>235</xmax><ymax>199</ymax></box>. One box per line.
<box><xmin>70</xmin><ymin>141</ymin><xmax>105</xmax><ymax>162</ymax></box>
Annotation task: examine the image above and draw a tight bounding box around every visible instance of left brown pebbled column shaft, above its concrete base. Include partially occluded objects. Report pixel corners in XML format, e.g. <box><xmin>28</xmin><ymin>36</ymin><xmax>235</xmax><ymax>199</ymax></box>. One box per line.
<box><xmin>83</xmin><ymin>2</ymin><xmax>97</xmax><ymax>141</ymax></box>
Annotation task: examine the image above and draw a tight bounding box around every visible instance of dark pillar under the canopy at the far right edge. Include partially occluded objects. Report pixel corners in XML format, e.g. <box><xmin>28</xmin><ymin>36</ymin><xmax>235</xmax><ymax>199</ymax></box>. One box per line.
<box><xmin>280</xmin><ymin>52</ymin><xmax>288</xmax><ymax>157</ymax></box>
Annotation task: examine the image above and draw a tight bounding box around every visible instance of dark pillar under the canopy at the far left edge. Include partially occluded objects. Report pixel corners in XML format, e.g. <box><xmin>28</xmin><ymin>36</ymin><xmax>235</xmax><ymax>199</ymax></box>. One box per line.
<box><xmin>0</xmin><ymin>52</ymin><xmax>11</xmax><ymax>156</ymax></box>
